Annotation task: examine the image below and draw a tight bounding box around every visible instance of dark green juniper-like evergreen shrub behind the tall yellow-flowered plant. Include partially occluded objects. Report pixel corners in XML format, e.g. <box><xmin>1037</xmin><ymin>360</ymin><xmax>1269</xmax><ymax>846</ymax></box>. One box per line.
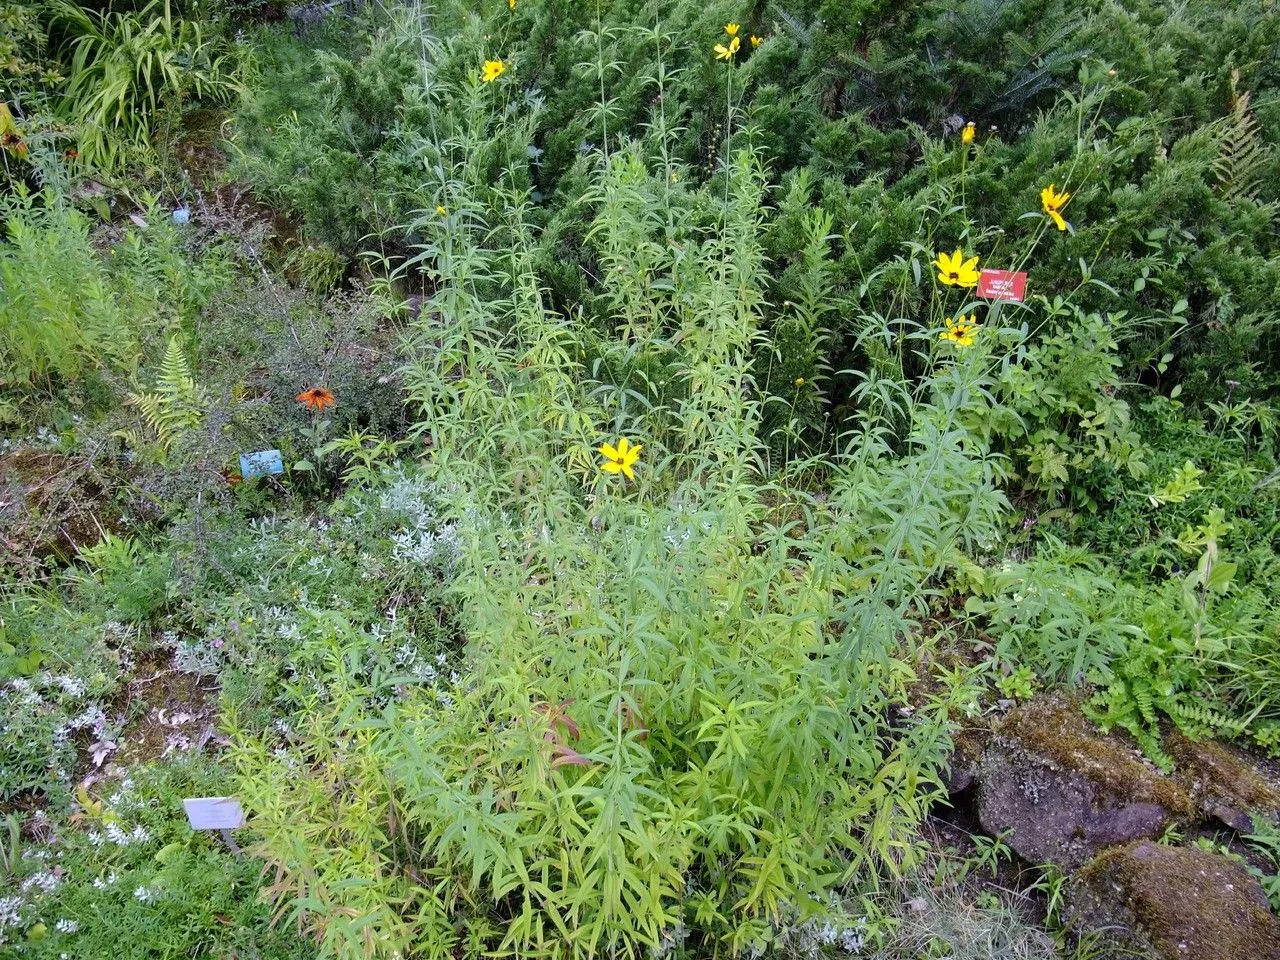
<box><xmin>237</xmin><ymin>0</ymin><xmax>1280</xmax><ymax>435</ymax></box>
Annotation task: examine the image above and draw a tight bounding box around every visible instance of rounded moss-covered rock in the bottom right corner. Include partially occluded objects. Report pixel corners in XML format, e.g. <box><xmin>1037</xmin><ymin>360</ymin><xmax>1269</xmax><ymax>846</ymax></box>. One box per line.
<box><xmin>1068</xmin><ymin>841</ymin><xmax>1280</xmax><ymax>960</ymax></box>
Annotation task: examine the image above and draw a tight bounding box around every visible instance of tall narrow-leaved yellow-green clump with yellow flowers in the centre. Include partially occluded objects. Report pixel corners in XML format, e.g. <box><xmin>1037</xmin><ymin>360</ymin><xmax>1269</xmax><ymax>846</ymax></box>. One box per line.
<box><xmin>236</xmin><ymin>132</ymin><xmax>1004</xmax><ymax>956</ymax></box>
